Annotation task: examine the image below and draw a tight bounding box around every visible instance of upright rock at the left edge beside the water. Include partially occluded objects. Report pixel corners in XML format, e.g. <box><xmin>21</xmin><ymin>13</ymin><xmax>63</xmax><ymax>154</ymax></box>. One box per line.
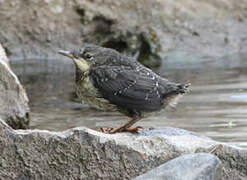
<box><xmin>0</xmin><ymin>45</ymin><xmax>29</xmax><ymax>129</ymax></box>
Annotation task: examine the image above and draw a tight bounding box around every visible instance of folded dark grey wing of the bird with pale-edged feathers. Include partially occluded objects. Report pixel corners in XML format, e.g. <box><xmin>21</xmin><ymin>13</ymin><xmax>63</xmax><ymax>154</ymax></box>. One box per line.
<box><xmin>90</xmin><ymin>66</ymin><xmax>163</xmax><ymax>111</ymax></box>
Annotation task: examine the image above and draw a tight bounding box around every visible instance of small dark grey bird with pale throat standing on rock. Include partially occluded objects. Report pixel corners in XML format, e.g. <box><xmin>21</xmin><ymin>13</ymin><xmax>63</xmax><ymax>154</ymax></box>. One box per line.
<box><xmin>59</xmin><ymin>44</ymin><xmax>190</xmax><ymax>134</ymax></box>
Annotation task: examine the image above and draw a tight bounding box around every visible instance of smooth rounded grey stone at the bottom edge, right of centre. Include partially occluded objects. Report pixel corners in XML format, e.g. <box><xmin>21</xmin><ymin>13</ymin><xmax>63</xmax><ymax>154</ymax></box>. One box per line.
<box><xmin>134</xmin><ymin>153</ymin><xmax>222</xmax><ymax>180</ymax></box>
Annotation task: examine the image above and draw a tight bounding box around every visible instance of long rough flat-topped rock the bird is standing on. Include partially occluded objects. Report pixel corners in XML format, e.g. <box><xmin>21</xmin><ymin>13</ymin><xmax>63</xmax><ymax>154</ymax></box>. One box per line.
<box><xmin>0</xmin><ymin>121</ymin><xmax>247</xmax><ymax>180</ymax></box>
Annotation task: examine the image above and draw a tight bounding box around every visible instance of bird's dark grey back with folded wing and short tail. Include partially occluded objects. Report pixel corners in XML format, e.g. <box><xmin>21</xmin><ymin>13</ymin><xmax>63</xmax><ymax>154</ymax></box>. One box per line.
<box><xmin>90</xmin><ymin>52</ymin><xmax>189</xmax><ymax>116</ymax></box>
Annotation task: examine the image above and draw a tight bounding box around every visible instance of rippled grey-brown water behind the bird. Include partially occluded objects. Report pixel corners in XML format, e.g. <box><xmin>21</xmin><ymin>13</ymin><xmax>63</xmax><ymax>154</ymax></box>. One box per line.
<box><xmin>12</xmin><ymin>55</ymin><xmax>247</xmax><ymax>147</ymax></box>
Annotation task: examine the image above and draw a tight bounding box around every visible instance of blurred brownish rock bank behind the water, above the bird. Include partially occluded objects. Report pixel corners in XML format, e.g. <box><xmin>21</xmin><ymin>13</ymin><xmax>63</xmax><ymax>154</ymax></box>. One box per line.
<box><xmin>0</xmin><ymin>0</ymin><xmax>247</xmax><ymax>66</ymax></box>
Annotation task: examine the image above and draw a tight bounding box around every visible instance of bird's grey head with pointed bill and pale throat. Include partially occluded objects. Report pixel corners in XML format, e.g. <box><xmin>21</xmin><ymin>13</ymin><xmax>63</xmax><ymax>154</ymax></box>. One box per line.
<box><xmin>59</xmin><ymin>45</ymin><xmax>114</xmax><ymax>72</ymax></box>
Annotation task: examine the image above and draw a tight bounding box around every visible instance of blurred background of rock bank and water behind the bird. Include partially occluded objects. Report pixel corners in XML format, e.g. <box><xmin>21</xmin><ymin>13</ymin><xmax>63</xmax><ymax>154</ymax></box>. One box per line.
<box><xmin>0</xmin><ymin>0</ymin><xmax>247</xmax><ymax>147</ymax></box>
